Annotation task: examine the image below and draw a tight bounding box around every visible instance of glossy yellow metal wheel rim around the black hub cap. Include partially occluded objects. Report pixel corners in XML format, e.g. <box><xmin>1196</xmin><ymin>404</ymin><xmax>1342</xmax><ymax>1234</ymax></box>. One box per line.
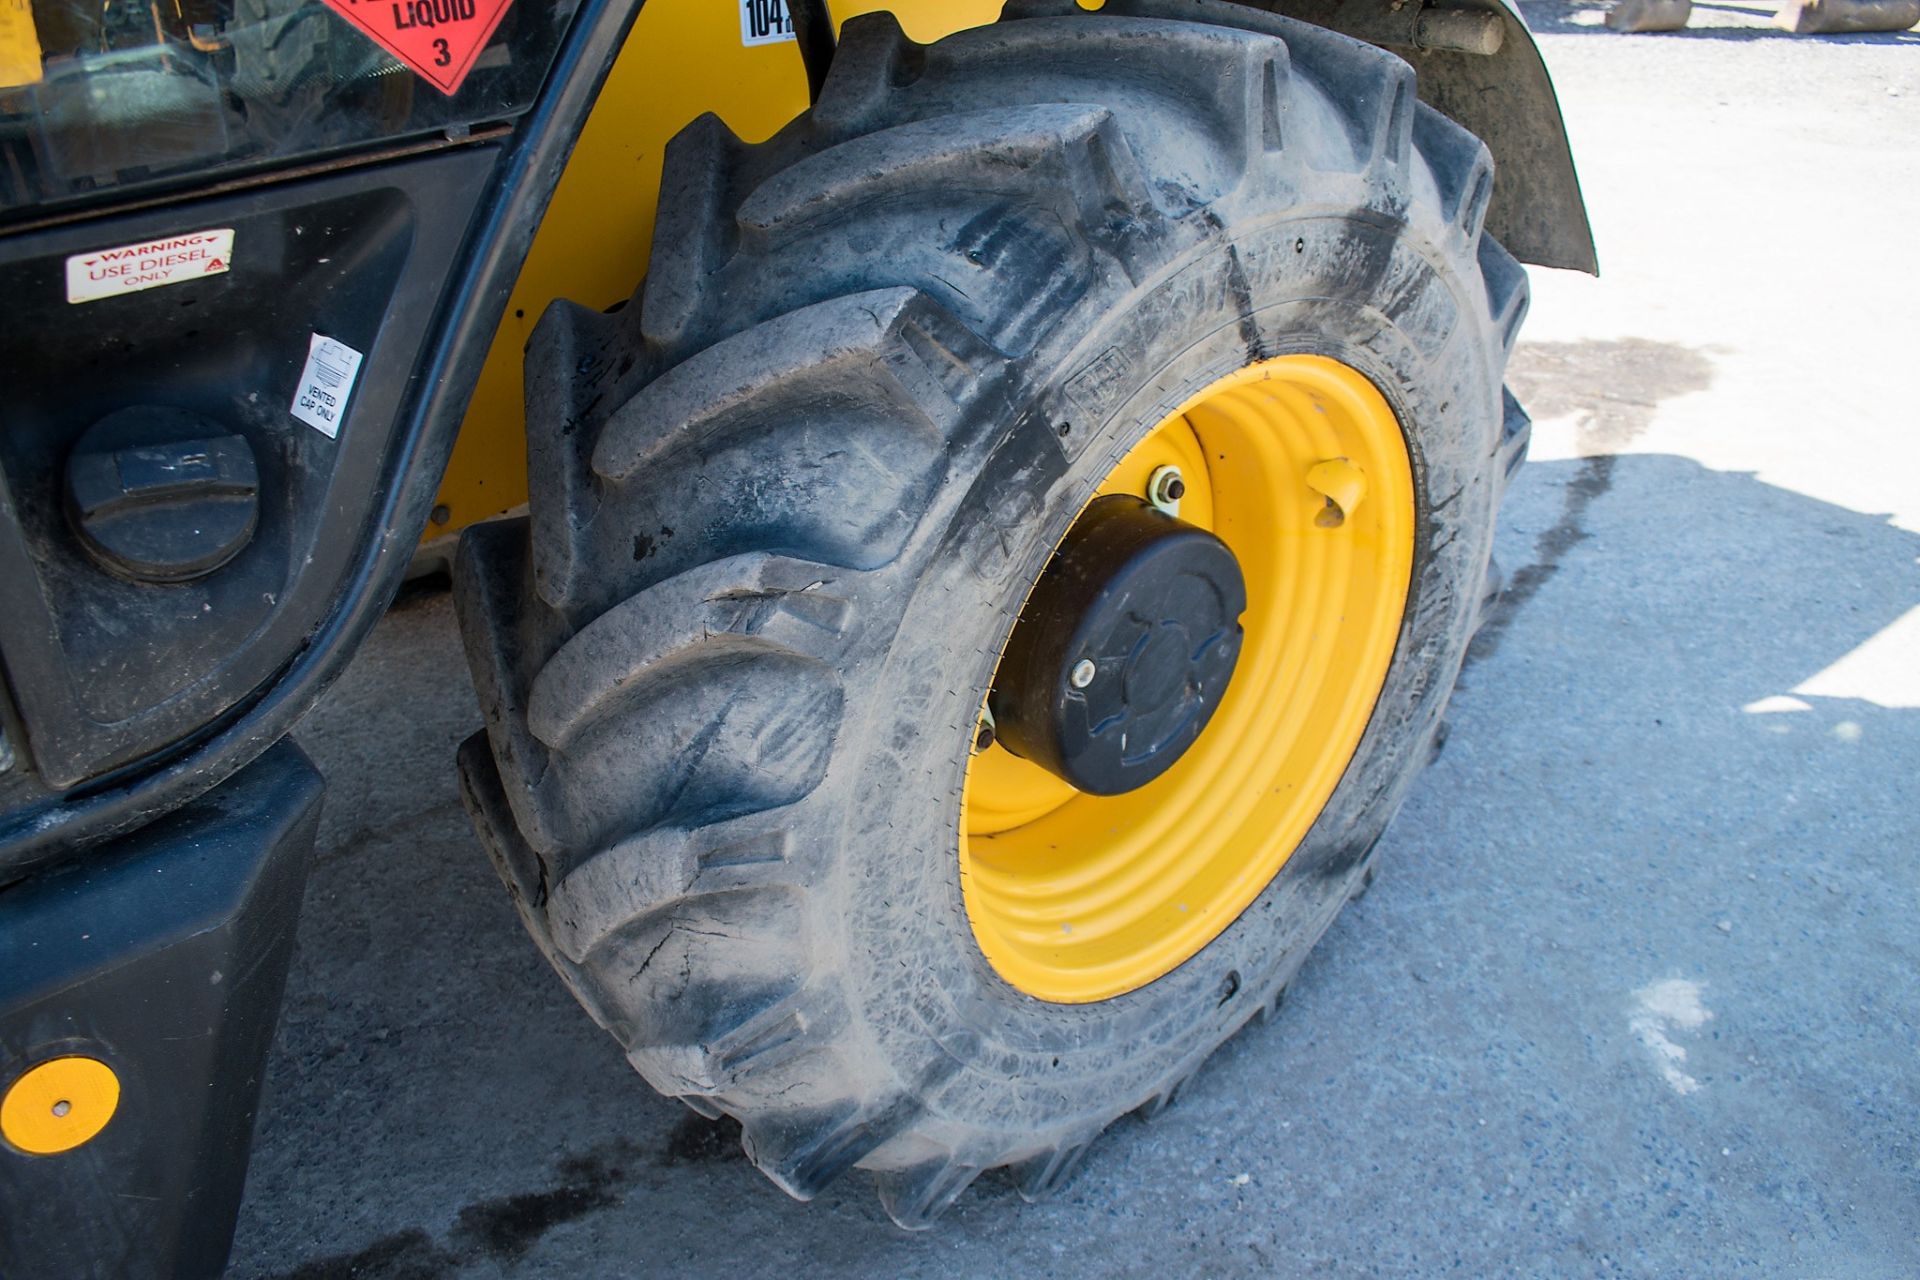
<box><xmin>960</xmin><ymin>355</ymin><xmax>1415</xmax><ymax>1004</ymax></box>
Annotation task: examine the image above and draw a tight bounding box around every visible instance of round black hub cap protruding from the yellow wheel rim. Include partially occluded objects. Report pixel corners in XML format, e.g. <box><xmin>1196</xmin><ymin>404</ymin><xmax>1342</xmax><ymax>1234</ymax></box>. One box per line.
<box><xmin>989</xmin><ymin>495</ymin><xmax>1246</xmax><ymax>796</ymax></box>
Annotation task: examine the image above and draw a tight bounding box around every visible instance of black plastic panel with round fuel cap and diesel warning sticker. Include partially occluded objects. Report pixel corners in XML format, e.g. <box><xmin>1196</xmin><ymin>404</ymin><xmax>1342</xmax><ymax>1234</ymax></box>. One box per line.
<box><xmin>0</xmin><ymin>146</ymin><xmax>495</xmax><ymax>789</ymax></box>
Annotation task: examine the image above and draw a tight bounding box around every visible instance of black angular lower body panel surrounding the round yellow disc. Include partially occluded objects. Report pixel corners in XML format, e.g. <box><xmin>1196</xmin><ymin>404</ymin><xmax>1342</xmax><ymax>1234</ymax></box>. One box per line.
<box><xmin>0</xmin><ymin>743</ymin><xmax>321</xmax><ymax>1280</ymax></box>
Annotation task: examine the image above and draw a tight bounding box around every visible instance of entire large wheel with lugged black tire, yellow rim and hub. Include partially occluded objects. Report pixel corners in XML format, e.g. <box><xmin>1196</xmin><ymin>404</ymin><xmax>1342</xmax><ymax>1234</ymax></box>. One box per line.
<box><xmin>457</xmin><ymin>0</ymin><xmax>1526</xmax><ymax>1226</ymax></box>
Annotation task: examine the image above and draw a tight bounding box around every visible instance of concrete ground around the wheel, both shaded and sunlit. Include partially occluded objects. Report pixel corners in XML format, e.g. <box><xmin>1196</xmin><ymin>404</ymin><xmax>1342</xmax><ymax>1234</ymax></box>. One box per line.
<box><xmin>234</xmin><ymin>4</ymin><xmax>1920</xmax><ymax>1280</ymax></box>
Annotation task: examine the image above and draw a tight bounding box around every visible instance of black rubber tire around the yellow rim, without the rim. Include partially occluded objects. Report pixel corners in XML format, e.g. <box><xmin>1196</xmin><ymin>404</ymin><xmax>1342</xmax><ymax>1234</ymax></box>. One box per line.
<box><xmin>457</xmin><ymin>0</ymin><xmax>1526</xmax><ymax>1226</ymax></box>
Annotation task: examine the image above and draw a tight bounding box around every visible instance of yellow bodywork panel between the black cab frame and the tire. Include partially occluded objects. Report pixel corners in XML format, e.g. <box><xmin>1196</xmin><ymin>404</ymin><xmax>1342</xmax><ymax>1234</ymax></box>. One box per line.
<box><xmin>435</xmin><ymin>0</ymin><xmax>1000</xmax><ymax>539</ymax></box>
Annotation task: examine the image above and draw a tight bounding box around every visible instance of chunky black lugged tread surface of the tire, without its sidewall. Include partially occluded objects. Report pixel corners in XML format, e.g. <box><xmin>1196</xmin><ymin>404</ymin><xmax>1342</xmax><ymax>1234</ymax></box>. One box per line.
<box><xmin>457</xmin><ymin>0</ymin><xmax>1526</xmax><ymax>1226</ymax></box>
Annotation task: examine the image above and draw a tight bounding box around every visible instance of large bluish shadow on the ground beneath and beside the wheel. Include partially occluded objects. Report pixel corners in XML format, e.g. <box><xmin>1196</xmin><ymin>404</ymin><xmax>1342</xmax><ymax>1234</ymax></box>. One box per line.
<box><xmin>234</xmin><ymin>443</ymin><xmax>1920</xmax><ymax>1280</ymax></box>
